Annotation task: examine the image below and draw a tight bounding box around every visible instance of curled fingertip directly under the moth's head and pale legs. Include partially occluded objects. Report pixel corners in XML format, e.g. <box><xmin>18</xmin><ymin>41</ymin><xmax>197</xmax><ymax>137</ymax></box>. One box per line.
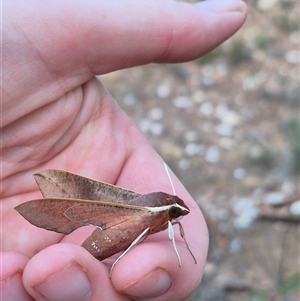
<box><xmin>112</xmin><ymin>239</ymin><xmax>204</xmax><ymax>301</ymax></box>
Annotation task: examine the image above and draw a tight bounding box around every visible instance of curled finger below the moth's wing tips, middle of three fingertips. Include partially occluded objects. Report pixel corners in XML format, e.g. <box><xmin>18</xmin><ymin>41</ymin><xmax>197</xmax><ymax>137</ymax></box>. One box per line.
<box><xmin>23</xmin><ymin>243</ymin><xmax>128</xmax><ymax>301</ymax></box>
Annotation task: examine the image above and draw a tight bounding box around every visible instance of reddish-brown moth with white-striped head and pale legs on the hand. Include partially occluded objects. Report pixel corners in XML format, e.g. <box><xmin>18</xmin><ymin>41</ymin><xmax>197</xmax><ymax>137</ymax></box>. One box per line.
<box><xmin>15</xmin><ymin>165</ymin><xmax>197</xmax><ymax>275</ymax></box>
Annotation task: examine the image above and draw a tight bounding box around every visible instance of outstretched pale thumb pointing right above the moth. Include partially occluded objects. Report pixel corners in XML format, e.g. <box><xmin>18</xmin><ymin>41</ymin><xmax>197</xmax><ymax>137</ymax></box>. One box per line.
<box><xmin>3</xmin><ymin>0</ymin><xmax>246</xmax><ymax>118</ymax></box>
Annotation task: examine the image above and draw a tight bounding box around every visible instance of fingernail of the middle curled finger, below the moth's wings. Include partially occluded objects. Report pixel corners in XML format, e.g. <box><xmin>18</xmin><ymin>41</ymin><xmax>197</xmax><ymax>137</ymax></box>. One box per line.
<box><xmin>34</xmin><ymin>262</ymin><xmax>91</xmax><ymax>301</ymax></box>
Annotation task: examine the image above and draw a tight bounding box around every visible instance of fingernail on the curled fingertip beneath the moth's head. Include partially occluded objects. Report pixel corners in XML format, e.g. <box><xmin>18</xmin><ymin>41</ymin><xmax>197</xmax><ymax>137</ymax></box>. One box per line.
<box><xmin>123</xmin><ymin>268</ymin><xmax>171</xmax><ymax>299</ymax></box>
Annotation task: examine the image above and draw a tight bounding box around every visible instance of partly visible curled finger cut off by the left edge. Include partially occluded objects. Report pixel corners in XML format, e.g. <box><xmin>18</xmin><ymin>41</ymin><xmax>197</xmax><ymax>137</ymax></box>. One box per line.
<box><xmin>0</xmin><ymin>252</ymin><xmax>33</xmax><ymax>301</ymax></box>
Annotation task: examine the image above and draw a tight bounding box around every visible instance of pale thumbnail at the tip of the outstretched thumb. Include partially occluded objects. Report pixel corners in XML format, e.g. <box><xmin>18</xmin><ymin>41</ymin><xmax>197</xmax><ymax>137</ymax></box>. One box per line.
<box><xmin>196</xmin><ymin>0</ymin><xmax>246</xmax><ymax>13</ymax></box>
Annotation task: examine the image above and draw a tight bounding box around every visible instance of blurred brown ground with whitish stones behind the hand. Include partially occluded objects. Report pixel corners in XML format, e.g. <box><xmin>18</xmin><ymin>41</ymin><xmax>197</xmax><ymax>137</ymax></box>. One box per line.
<box><xmin>101</xmin><ymin>0</ymin><xmax>300</xmax><ymax>301</ymax></box>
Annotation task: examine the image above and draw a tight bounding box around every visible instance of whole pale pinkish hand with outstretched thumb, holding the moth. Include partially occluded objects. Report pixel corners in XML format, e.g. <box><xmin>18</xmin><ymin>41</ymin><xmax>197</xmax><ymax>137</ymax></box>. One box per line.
<box><xmin>1</xmin><ymin>0</ymin><xmax>246</xmax><ymax>301</ymax></box>
